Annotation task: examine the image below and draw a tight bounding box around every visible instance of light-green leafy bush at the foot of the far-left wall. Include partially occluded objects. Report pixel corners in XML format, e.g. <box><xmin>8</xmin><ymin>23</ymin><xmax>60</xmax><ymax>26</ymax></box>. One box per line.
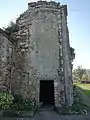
<box><xmin>0</xmin><ymin>93</ymin><xmax>14</xmax><ymax>110</ymax></box>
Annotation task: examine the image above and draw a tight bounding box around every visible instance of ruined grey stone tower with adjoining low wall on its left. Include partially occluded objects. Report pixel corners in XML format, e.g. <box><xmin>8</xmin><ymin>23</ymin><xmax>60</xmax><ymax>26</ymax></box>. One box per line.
<box><xmin>0</xmin><ymin>1</ymin><xmax>74</xmax><ymax>107</ymax></box>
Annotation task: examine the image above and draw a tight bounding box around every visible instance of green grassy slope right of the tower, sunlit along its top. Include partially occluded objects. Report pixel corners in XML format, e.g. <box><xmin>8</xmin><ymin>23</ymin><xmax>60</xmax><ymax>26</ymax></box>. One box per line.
<box><xmin>75</xmin><ymin>83</ymin><xmax>90</xmax><ymax>107</ymax></box>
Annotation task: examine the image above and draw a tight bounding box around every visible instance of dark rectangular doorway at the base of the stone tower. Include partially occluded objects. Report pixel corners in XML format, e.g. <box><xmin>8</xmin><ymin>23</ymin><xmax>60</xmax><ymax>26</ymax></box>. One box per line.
<box><xmin>40</xmin><ymin>80</ymin><xmax>54</xmax><ymax>105</ymax></box>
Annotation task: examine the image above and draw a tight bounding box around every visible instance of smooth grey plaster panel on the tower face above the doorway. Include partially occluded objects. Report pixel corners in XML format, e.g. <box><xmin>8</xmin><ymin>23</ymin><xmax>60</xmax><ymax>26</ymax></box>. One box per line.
<box><xmin>29</xmin><ymin>10</ymin><xmax>59</xmax><ymax>80</ymax></box>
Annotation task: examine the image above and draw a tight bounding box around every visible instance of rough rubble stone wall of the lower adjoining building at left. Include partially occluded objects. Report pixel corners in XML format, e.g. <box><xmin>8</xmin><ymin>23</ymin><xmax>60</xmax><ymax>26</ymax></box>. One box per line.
<box><xmin>0</xmin><ymin>29</ymin><xmax>10</xmax><ymax>92</ymax></box>
